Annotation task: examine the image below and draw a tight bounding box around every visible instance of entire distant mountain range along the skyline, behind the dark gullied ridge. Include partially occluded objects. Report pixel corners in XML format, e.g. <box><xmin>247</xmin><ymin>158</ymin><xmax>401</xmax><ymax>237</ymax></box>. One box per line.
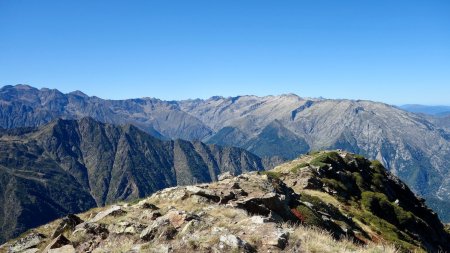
<box><xmin>0</xmin><ymin>85</ymin><xmax>450</xmax><ymax>221</ymax></box>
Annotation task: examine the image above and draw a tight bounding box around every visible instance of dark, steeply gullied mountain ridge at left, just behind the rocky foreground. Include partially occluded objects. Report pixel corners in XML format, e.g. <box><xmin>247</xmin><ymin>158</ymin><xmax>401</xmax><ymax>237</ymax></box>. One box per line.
<box><xmin>0</xmin><ymin>118</ymin><xmax>263</xmax><ymax>244</ymax></box>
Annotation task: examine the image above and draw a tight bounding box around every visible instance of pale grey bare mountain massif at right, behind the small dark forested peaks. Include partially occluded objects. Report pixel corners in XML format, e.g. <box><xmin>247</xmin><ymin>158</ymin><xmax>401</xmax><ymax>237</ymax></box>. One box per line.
<box><xmin>180</xmin><ymin>95</ymin><xmax>450</xmax><ymax>220</ymax></box>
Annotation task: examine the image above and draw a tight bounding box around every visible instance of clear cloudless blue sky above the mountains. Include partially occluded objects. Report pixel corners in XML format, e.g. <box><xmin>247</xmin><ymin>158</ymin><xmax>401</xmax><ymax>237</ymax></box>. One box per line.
<box><xmin>0</xmin><ymin>0</ymin><xmax>450</xmax><ymax>105</ymax></box>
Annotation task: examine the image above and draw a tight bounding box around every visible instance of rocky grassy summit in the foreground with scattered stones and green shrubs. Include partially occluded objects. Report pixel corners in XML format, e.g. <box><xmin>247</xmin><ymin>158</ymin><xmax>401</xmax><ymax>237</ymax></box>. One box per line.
<box><xmin>0</xmin><ymin>151</ymin><xmax>450</xmax><ymax>252</ymax></box>
